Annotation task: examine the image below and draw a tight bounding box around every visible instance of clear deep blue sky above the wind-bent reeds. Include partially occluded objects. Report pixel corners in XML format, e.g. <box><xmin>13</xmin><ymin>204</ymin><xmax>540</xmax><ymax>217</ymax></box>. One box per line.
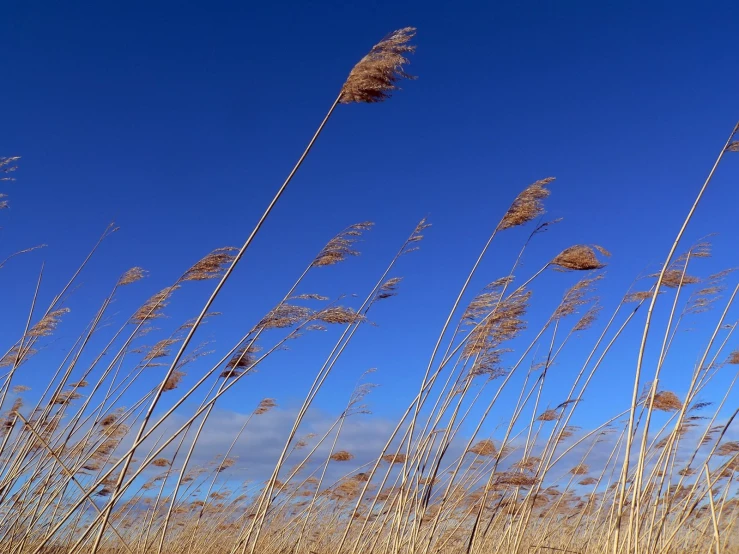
<box><xmin>0</xmin><ymin>0</ymin><xmax>739</xmax><ymax>430</ymax></box>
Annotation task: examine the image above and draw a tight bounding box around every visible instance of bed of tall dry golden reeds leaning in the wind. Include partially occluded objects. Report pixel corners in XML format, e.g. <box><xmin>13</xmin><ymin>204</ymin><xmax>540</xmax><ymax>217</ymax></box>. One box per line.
<box><xmin>0</xmin><ymin>28</ymin><xmax>739</xmax><ymax>554</ymax></box>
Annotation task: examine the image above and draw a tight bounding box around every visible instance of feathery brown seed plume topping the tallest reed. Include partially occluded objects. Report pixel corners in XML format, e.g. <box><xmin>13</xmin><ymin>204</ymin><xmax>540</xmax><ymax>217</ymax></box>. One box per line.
<box><xmin>339</xmin><ymin>27</ymin><xmax>416</xmax><ymax>104</ymax></box>
